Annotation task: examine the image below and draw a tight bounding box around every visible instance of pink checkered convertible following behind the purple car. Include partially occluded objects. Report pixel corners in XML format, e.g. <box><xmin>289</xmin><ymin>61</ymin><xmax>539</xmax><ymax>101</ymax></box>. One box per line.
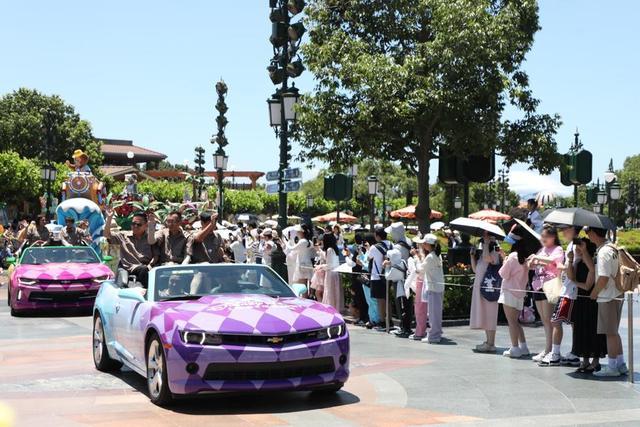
<box><xmin>7</xmin><ymin>246</ymin><xmax>113</xmax><ymax>316</ymax></box>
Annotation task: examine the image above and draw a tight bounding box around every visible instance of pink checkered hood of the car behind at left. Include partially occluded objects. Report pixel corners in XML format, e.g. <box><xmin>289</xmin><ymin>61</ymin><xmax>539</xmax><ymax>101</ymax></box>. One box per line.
<box><xmin>15</xmin><ymin>263</ymin><xmax>113</xmax><ymax>280</ymax></box>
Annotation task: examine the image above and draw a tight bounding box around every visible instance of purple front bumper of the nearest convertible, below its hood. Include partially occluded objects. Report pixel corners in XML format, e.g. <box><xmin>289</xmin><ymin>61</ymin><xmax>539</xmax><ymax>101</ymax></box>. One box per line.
<box><xmin>165</xmin><ymin>334</ymin><xmax>349</xmax><ymax>394</ymax></box>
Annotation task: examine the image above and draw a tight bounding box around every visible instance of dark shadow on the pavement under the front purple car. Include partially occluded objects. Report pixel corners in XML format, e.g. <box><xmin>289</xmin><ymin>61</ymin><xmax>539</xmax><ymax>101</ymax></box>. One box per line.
<box><xmin>113</xmin><ymin>368</ymin><xmax>360</xmax><ymax>415</ymax></box>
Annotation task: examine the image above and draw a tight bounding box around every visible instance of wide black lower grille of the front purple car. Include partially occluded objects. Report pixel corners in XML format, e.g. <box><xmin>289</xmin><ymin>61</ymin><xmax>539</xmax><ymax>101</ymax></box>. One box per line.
<box><xmin>203</xmin><ymin>357</ymin><xmax>335</xmax><ymax>381</ymax></box>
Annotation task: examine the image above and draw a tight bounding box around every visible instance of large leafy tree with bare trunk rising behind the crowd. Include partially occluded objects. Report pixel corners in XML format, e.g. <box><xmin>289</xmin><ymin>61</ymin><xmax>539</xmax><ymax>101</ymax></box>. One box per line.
<box><xmin>295</xmin><ymin>0</ymin><xmax>560</xmax><ymax>231</ymax></box>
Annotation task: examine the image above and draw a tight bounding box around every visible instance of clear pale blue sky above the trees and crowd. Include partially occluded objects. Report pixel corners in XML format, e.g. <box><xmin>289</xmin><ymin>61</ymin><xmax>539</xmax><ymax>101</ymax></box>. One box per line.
<box><xmin>0</xmin><ymin>0</ymin><xmax>640</xmax><ymax>194</ymax></box>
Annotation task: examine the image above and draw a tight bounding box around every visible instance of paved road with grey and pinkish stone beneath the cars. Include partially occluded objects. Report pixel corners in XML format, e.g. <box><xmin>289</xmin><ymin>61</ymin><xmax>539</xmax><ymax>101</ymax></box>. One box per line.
<box><xmin>0</xmin><ymin>278</ymin><xmax>640</xmax><ymax>427</ymax></box>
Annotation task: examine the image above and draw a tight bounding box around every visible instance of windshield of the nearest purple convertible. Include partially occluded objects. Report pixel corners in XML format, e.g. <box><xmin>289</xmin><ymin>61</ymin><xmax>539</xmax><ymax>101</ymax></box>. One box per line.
<box><xmin>154</xmin><ymin>264</ymin><xmax>295</xmax><ymax>301</ymax></box>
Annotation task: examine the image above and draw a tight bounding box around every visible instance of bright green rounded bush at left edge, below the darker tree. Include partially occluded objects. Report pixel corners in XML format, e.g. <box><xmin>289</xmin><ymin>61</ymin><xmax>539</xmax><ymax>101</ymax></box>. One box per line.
<box><xmin>0</xmin><ymin>151</ymin><xmax>42</xmax><ymax>203</ymax></box>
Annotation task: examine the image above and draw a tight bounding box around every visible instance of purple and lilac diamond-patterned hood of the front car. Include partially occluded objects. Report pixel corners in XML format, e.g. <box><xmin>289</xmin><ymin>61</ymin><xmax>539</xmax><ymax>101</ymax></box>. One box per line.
<box><xmin>151</xmin><ymin>294</ymin><xmax>344</xmax><ymax>335</ymax></box>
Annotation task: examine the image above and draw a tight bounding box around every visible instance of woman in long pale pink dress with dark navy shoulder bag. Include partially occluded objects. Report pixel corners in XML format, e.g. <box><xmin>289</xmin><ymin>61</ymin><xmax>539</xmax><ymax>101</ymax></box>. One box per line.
<box><xmin>469</xmin><ymin>232</ymin><xmax>501</xmax><ymax>353</ymax></box>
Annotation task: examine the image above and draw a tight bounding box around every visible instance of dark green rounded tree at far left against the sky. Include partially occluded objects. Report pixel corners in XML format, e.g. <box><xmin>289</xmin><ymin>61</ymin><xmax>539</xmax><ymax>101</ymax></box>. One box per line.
<box><xmin>0</xmin><ymin>88</ymin><xmax>103</xmax><ymax>169</ymax></box>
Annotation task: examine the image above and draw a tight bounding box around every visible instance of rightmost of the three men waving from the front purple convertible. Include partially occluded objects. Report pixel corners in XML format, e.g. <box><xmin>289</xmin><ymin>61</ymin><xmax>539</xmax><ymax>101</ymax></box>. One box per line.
<box><xmin>187</xmin><ymin>212</ymin><xmax>226</xmax><ymax>264</ymax></box>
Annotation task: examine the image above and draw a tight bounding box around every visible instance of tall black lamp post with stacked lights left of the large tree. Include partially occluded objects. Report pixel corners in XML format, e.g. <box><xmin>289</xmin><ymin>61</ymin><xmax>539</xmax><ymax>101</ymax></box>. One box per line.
<box><xmin>267</xmin><ymin>0</ymin><xmax>306</xmax><ymax>228</ymax></box>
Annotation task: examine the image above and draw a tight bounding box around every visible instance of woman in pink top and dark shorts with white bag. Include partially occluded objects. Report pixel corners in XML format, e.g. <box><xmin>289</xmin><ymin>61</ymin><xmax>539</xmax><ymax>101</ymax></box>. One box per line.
<box><xmin>528</xmin><ymin>224</ymin><xmax>564</xmax><ymax>366</ymax></box>
